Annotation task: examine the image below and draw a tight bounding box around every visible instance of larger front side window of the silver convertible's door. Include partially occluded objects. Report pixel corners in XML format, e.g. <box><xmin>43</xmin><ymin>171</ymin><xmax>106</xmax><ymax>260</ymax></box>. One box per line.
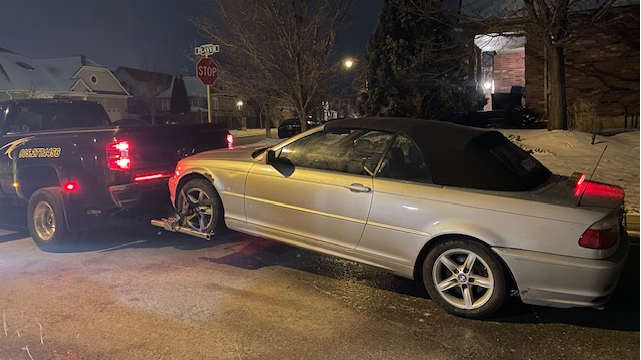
<box><xmin>278</xmin><ymin>129</ymin><xmax>393</xmax><ymax>176</ymax></box>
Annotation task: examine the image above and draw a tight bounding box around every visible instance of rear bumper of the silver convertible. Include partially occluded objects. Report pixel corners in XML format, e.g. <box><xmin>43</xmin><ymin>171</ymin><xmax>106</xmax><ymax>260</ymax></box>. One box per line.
<box><xmin>494</xmin><ymin>236</ymin><xmax>629</xmax><ymax>308</ymax></box>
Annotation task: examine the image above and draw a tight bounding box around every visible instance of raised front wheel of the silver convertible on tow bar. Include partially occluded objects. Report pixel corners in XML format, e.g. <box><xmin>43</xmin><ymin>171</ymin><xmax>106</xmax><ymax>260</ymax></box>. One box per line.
<box><xmin>177</xmin><ymin>179</ymin><xmax>225</xmax><ymax>234</ymax></box>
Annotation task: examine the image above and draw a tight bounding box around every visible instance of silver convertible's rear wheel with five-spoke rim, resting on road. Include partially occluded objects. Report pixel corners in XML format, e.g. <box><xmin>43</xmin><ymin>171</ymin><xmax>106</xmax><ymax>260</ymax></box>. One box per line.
<box><xmin>423</xmin><ymin>239</ymin><xmax>507</xmax><ymax>319</ymax></box>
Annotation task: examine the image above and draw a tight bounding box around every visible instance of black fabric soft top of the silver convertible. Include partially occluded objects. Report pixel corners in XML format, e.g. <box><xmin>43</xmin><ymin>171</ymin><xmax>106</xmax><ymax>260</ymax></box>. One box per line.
<box><xmin>325</xmin><ymin>118</ymin><xmax>552</xmax><ymax>191</ymax></box>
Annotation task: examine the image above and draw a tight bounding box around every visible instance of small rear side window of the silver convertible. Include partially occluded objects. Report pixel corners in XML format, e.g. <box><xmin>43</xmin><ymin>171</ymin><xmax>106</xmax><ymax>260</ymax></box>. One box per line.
<box><xmin>376</xmin><ymin>135</ymin><xmax>432</xmax><ymax>183</ymax></box>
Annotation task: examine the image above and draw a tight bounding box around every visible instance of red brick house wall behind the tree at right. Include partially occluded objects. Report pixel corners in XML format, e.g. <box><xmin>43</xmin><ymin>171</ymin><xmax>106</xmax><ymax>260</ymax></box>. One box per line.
<box><xmin>525</xmin><ymin>6</ymin><xmax>641</xmax><ymax>124</ymax></box>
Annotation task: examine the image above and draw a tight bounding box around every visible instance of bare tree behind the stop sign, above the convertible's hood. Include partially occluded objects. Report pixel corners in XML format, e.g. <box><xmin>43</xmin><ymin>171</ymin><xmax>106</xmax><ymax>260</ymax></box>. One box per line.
<box><xmin>193</xmin><ymin>0</ymin><xmax>353</xmax><ymax>130</ymax></box>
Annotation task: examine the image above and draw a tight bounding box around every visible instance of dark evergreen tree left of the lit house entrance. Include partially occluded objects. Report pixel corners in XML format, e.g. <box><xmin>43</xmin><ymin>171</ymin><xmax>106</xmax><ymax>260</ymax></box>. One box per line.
<box><xmin>360</xmin><ymin>0</ymin><xmax>482</xmax><ymax>120</ymax></box>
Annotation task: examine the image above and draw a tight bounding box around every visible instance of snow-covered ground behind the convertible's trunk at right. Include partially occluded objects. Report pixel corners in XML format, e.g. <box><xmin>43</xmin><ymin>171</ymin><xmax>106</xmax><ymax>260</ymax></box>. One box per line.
<box><xmin>501</xmin><ymin>129</ymin><xmax>639</xmax><ymax>214</ymax></box>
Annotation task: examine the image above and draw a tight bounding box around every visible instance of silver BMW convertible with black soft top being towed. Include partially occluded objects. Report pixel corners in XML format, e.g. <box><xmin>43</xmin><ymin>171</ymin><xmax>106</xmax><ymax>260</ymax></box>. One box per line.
<box><xmin>169</xmin><ymin>118</ymin><xmax>629</xmax><ymax>319</ymax></box>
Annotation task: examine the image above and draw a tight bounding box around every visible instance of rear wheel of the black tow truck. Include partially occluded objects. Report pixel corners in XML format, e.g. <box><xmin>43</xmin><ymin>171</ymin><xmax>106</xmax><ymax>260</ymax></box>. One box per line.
<box><xmin>27</xmin><ymin>188</ymin><xmax>69</xmax><ymax>251</ymax></box>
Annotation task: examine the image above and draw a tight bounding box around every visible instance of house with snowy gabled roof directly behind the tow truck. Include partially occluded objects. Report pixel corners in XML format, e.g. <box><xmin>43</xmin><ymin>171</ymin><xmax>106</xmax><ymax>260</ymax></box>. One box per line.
<box><xmin>0</xmin><ymin>48</ymin><xmax>130</xmax><ymax>121</ymax></box>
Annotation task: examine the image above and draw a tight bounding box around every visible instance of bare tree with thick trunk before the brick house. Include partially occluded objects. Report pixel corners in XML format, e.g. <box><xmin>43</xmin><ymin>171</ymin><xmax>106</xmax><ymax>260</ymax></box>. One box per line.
<box><xmin>436</xmin><ymin>0</ymin><xmax>638</xmax><ymax>129</ymax></box>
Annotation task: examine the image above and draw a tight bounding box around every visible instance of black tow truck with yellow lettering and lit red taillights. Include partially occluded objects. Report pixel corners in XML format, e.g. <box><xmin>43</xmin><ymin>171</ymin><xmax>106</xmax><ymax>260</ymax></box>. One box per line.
<box><xmin>0</xmin><ymin>99</ymin><xmax>233</xmax><ymax>251</ymax></box>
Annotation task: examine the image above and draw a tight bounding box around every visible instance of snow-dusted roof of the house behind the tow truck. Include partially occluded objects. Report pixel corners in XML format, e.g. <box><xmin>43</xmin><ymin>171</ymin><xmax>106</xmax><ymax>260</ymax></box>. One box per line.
<box><xmin>0</xmin><ymin>48</ymin><xmax>104</xmax><ymax>91</ymax></box>
